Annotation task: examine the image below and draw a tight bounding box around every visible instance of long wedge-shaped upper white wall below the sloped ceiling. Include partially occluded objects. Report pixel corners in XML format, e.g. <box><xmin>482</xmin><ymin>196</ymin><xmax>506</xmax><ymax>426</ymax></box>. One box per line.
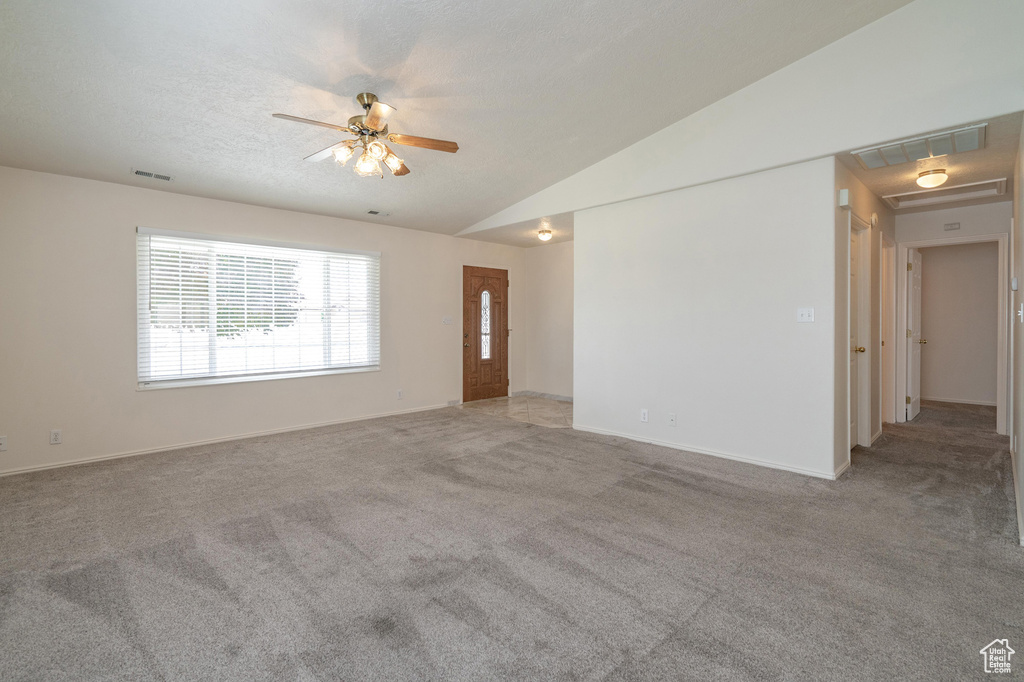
<box><xmin>469</xmin><ymin>0</ymin><xmax>1024</xmax><ymax>230</ymax></box>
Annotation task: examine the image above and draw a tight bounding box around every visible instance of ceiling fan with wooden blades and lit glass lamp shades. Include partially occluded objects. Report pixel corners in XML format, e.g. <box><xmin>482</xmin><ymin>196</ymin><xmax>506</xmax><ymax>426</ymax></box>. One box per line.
<box><xmin>273</xmin><ymin>92</ymin><xmax>459</xmax><ymax>177</ymax></box>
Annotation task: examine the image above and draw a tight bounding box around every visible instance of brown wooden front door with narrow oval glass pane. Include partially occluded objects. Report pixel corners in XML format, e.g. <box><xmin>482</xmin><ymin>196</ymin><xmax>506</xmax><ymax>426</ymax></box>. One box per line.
<box><xmin>462</xmin><ymin>265</ymin><xmax>509</xmax><ymax>402</ymax></box>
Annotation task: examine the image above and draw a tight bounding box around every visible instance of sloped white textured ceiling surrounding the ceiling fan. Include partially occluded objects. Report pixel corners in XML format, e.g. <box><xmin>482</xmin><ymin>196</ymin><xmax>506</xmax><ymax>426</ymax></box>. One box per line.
<box><xmin>0</xmin><ymin>0</ymin><xmax>907</xmax><ymax>233</ymax></box>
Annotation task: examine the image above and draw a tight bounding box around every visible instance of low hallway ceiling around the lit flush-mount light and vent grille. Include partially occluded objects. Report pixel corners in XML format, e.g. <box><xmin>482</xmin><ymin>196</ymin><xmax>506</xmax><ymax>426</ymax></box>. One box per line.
<box><xmin>839</xmin><ymin>113</ymin><xmax>1022</xmax><ymax>213</ymax></box>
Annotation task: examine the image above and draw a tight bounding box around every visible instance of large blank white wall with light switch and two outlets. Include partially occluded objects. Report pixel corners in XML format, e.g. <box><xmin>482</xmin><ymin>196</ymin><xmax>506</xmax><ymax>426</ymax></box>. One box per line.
<box><xmin>573</xmin><ymin>158</ymin><xmax>836</xmax><ymax>476</ymax></box>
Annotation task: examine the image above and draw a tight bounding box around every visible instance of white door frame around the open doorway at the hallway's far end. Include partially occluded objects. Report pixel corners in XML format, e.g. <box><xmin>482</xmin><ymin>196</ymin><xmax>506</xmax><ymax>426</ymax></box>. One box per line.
<box><xmin>896</xmin><ymin>232</ymin><xmax>1010</xmax><ymax>428</ymax></box>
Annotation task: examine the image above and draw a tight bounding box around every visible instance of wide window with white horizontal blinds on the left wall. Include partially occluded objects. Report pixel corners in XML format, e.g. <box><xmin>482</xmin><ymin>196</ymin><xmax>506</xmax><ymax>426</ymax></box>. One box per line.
<box><xmin>137</xmin><ymin>227</ymin><xmax>380</xmax><ymax>388</ymax></box>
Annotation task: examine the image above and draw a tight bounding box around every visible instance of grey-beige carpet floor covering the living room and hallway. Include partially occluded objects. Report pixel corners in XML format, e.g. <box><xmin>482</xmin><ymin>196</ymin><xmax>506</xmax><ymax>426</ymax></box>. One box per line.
<box><xmin>0</xmin><ymin>403</ymin><xmax>1024</xmax><ymax>680</ymax></box>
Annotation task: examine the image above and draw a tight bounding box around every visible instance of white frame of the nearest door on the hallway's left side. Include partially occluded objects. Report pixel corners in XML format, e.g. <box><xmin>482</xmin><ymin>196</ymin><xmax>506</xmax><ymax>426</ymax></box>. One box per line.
<box><xmin>846</xmin><ymin>211</ymin><xmax>874</xmax><ymax>447</ymax></box>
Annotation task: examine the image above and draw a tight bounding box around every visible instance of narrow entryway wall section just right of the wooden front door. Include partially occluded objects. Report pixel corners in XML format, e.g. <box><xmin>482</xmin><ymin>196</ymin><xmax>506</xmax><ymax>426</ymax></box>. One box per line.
<box><xmin>528</xmin><ymin>242</ymin><xmax>572</xmax><ymax>397</ymax></box>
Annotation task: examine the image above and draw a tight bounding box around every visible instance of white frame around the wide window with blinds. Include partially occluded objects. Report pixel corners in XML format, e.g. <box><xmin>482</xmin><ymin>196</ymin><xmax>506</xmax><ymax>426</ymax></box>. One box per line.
<box><xmin>135</xmin><ymin>225</ymin><xmax>384</xmax><ymax>391</ymax></box>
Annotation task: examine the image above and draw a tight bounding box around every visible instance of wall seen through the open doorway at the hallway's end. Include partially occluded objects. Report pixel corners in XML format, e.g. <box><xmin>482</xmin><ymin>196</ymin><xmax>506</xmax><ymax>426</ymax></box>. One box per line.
<box><xmin>921</xmin><ymin>242</ymin><xmax>999</xmax><ymax>406</ymax></box>
